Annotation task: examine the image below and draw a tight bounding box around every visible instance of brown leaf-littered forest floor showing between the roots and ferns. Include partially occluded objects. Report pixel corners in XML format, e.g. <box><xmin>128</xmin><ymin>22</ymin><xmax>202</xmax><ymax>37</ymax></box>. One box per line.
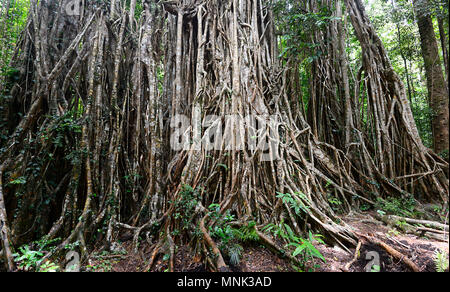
<box><xmin>87</xmin><ymin>214</ymin><xmax>449</xmax><ymax>272</ymax></box>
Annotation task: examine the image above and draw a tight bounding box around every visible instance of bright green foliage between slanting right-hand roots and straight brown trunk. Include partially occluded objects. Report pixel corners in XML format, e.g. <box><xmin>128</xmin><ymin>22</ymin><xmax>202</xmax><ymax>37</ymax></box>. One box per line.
<box><xmin>364</xmin><ymin>0</ymin><xmax>438</xmax><ymax>147</ymax></box>
